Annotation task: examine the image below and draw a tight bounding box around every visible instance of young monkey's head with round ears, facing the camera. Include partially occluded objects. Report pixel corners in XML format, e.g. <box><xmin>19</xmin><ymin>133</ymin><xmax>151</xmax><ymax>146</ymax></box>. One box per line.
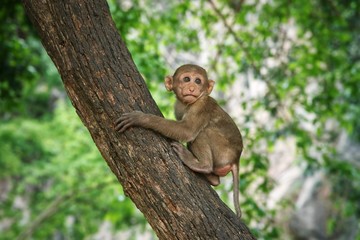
<box><xmin>165</xmin><ymin>64</ymin><xmax>215</xmax><ymax>104</ymax></box>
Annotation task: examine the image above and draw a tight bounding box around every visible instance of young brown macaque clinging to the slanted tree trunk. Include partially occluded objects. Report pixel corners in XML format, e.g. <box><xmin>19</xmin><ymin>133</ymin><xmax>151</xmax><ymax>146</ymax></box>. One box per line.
<box><xmin>115</xmin><ymin>64</ymin><xmax>243</xmax><ymax>217</ymax></box>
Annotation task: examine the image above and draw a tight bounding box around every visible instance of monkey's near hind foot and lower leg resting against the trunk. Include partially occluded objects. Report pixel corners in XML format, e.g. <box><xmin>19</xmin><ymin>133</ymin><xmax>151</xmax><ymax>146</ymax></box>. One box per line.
<box><xmin>171</xmin><ymin>142</ymin><xmax>213</xmax><ymax>174</ymax></box>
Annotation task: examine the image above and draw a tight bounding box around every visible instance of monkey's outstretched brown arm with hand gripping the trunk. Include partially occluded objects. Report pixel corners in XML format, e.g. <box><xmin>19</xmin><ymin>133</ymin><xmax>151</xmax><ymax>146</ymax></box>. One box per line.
<box><xmin>115</xmin><ymin>111</ymin><xmax>201</xmax><ymax>142</ymax></box>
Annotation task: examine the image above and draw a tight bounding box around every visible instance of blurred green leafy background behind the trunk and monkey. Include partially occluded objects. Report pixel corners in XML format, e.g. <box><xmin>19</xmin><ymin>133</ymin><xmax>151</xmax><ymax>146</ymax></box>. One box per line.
<box><xmin>0</xmin><ymin>0</ymin><xmax>360</xmax><ymax>240</ymax></box>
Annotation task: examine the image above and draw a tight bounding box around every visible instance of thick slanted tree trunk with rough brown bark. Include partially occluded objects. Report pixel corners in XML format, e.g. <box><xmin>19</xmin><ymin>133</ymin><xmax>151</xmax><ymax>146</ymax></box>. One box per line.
<box><xmin>23</xmin><ymin>0</ymin><xmax>254</xmax><ymax>240</ymax></box>
